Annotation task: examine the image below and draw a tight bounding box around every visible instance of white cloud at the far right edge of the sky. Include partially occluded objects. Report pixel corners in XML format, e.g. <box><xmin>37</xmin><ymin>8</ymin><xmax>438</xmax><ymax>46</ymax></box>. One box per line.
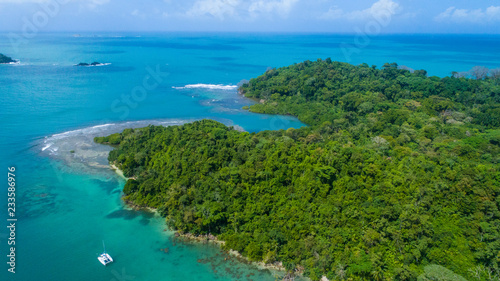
<box><xmin>435</xmin><ymin>6</ymin><xmax>500</xmax><ymax>23</ymax></box>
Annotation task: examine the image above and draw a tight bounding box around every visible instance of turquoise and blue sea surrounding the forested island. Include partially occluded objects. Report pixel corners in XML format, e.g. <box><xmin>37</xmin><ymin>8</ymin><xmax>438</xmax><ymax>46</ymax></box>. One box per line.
<box><xmin>0</xmin><ymin>33</ymin><xmax>500</xmax><ymax>281</ymax></box>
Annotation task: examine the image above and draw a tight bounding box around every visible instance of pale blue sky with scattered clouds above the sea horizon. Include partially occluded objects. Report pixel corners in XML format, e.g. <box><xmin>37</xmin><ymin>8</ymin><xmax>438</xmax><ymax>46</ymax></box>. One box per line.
<box><xmin>0</xmin><ymin>0</ymin><xmax>500</xmax><ymax>34</ymax></box>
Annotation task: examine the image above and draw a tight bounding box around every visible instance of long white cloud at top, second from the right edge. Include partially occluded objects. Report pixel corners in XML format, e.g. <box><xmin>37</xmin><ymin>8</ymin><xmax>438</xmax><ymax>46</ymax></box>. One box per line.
<box><xmin>320</xmin><ymin>0</ymin><xmax>401</xmax><ymax>20</ymax></box>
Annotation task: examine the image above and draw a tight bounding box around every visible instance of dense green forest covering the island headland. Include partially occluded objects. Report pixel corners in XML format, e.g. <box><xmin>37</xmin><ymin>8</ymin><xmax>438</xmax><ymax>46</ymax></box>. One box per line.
<box><xmin>96</xmin><ymin>59</ymin><xmax>500</xmax><ymax>280</ymax></box>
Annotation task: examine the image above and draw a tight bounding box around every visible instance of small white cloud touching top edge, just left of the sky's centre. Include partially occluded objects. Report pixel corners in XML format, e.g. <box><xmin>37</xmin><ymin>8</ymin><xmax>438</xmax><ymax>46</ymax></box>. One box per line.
<box><xmin>186</xmin><ymin>0</ymin><xmax>241</xmax><ymax>20</ymax></box>
